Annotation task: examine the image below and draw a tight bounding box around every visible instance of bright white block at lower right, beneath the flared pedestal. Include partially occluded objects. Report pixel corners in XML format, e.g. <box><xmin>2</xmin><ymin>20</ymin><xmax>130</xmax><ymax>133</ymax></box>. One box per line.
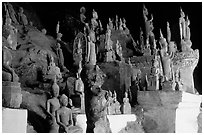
<box><xmin>175</xmin><ymin>92</ymin><xmax>202</xmax><ymax>133</ymax></box>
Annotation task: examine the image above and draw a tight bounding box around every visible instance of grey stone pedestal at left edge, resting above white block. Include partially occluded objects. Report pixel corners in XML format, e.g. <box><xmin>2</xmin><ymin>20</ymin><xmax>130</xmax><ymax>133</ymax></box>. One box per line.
<box><xmin>2</xmin><ymin>82</ymin><xmax>22</xmax><ymax>108</ymax></box>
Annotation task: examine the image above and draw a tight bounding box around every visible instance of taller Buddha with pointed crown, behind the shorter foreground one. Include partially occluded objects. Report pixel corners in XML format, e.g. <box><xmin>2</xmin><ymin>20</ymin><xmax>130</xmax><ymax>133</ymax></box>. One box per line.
<box><xmin>46</xmin><ymin>77</ymin><xmax>60</xmax><ymax>133</ymax></box>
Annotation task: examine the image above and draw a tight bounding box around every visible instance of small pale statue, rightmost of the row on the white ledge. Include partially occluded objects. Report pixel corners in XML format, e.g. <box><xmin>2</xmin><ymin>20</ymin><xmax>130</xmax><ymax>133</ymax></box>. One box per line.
<box><xmin>121</xmin><ymin>92</ymin><xmax>131</xmax><ymax>114</ymax></box>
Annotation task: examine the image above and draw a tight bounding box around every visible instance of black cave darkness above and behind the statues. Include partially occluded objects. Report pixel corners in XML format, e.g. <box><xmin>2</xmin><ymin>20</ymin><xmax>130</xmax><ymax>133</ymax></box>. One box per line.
<box><xmin>6</xmin><ymin>2</ymin><xmax>202</xmax><ymax>94</ymax></box>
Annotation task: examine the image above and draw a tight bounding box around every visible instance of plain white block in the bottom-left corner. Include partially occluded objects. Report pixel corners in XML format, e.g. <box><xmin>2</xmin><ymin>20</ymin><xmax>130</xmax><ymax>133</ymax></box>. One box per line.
<box><xmin>2</xmin><ymin>108</ymin><xmax>27</xmax><ymax>133</ymax></box>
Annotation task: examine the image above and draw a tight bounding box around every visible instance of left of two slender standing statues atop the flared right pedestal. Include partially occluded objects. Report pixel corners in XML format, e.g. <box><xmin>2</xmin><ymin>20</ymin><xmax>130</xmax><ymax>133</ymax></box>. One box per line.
<box><xmin>179</xmin><ymin>8</ymin><xmax>186</xmax><ymax>39</ymax></box>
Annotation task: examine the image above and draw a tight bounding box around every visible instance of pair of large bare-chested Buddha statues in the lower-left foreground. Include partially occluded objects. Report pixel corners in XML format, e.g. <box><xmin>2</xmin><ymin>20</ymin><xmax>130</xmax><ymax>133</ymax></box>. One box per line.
<box><xmin>46</xmin><ymin>78</ymin><xmax>74</xmax><ymax>133</ymax></box>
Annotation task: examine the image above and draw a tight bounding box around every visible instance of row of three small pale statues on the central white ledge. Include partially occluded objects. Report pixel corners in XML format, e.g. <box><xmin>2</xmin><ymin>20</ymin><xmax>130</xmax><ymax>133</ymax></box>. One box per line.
<box><xmin>107</xmin><ymin>91</ymin><xmax>131</xmax><ymax>115</ymax></box>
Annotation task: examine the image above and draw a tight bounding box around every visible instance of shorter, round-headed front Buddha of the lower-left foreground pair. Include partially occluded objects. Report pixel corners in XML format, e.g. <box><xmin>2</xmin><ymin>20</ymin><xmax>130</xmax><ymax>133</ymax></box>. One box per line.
<box><xmin>56</xmin><ymin>94</ymin><xmax>73</xmax><ymax>133</ymax></box>
